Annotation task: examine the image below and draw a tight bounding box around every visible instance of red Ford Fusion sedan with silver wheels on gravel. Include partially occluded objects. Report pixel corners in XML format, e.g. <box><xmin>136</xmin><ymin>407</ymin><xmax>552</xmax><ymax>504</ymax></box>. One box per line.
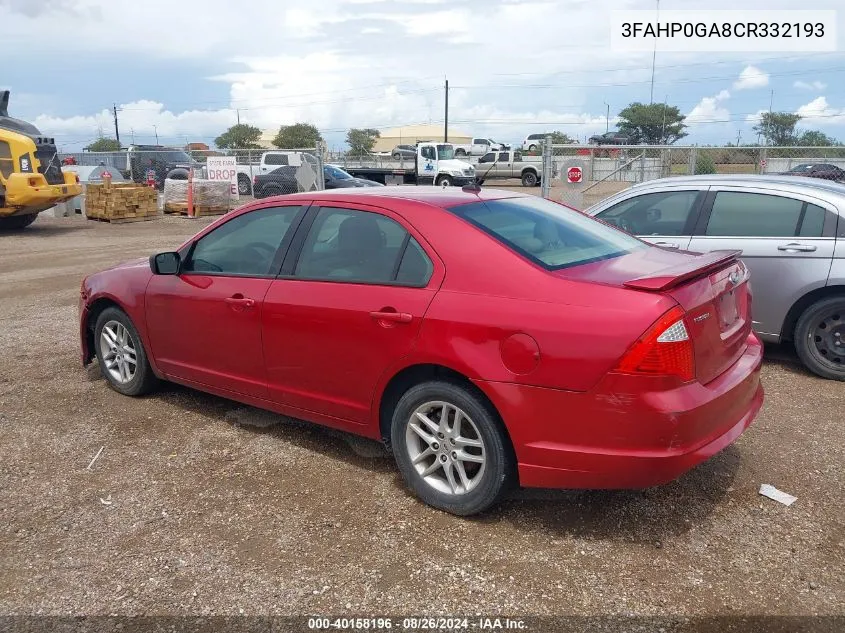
<box><xmin>79</xmin><ymin>187</ymin><xmax>763</xmax><ymax>515</ymax></box>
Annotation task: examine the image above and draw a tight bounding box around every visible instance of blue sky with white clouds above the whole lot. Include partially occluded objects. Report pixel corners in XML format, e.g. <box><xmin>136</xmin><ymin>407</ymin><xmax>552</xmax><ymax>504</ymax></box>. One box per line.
<box><xmin>0</xmin><ymin>0</ymin><xmax>845</xmax><ymax>151</ymax></box>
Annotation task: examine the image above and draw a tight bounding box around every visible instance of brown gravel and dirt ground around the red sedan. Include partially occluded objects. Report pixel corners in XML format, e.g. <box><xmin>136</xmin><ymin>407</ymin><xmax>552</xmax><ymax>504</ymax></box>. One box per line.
<box><xmin>0</xmin><ymin>211</ymin><xmax>845</xmax><ymax>615</ymax></box>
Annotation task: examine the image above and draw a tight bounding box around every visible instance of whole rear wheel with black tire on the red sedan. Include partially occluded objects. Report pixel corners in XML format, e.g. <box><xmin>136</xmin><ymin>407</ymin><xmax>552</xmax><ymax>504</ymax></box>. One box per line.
<box><xmin>390</xmin><ymin>381</ymin><xmax>516</xmax><ymax>516</ymax></box>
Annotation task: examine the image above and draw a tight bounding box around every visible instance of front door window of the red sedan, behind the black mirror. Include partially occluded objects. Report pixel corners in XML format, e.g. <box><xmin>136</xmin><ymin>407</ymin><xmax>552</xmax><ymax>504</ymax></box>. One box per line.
<box><xmin>184</xmin><ymin>206</ymin><xmax>302</xmax><ymax>277</ymax></box>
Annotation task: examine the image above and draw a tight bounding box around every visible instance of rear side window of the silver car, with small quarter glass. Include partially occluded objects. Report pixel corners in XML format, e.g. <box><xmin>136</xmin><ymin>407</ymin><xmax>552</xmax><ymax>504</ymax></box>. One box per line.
<box><xmin>705</xmin><ymin>191</ymin><xmax>812</xmax><ymax>237</ymax></box>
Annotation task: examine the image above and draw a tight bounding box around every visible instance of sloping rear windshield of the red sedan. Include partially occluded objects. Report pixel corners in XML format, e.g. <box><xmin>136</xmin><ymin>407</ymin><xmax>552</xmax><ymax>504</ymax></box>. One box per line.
<box><xmin>449</xmin><ymin>196</ymin><xmax>648</xmax><ymax>270</ymax></box>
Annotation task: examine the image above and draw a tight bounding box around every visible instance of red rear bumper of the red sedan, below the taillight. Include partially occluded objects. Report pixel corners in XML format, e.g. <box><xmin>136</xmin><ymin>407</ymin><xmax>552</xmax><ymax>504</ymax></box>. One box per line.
<box><xmin>478</xmin><ymin>335</ymin><xmax>763</xmax><ymax>489</ymax></box>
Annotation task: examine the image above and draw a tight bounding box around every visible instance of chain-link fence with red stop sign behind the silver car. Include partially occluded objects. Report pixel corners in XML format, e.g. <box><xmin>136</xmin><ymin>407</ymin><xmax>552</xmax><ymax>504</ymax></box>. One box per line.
<box><xmin>543</xmin><ymin>140</ymin><xmax>845</xmax><ymax>209</ymax></box>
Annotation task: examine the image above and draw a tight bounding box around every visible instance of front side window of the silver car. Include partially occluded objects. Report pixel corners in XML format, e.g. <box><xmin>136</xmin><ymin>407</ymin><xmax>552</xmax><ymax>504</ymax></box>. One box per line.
<box><xmin>596</xmin><ymin>191</ymin><xmax>703</xmax><ymax>236</ymax></box>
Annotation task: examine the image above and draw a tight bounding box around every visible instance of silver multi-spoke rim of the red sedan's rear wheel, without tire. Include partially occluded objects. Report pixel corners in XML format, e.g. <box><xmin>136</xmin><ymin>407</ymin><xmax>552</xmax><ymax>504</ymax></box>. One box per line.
<box><xmin>405</xmin><ymin>401</ymin><xmax>486</xmax><ymax>496</ymax></box>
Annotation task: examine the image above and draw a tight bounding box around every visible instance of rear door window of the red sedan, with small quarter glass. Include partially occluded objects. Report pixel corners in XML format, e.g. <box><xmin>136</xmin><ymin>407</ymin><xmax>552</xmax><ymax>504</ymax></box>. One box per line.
<box><xmin>294</xmin><ymin>207</ymin><xmax>430</xmax><ymax>283</ymax></box>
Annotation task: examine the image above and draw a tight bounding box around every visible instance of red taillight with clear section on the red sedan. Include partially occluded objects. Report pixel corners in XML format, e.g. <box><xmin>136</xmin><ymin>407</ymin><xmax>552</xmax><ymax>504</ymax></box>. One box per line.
<box><xmin>616</xmin><ymin>306</ymin><xmax>695</xmax><ymax>382</ymax></box>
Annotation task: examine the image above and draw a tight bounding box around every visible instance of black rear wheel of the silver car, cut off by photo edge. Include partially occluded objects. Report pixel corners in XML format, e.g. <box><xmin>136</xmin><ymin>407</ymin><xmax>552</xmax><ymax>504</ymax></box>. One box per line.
<box><xmin>794</xmin><ymin>296</ymin><xmax>845</xmax><ymax>381</ymax></box>
